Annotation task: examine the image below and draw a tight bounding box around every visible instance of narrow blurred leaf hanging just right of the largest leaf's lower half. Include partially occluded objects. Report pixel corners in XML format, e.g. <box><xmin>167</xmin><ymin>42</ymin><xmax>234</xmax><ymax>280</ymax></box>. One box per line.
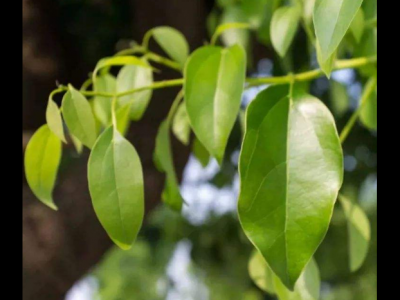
<box><xmin>339</xmin><ymin>195</ymin><xmax>371</xmax><ymax>272</ymax></box>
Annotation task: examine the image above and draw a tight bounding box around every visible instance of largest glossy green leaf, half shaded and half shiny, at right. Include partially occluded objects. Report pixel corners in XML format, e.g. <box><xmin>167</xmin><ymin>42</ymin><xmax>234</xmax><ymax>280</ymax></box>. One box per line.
<box><xmin>238</xmin><ymin>86</ymin><xmax>343</xmax><ymax>289</ymax></box>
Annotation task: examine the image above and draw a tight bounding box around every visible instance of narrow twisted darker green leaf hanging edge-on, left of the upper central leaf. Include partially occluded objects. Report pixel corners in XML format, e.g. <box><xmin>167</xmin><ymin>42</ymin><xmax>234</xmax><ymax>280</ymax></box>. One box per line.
<box><xmin>154</xmin><ymin>120</ymin><xmax>183</xmax><ymax>212</ymax></box>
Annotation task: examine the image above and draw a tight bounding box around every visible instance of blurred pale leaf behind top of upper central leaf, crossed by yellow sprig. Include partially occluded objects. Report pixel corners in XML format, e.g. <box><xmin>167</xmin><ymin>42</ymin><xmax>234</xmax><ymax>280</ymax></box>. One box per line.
<box><xmin>219</xmin><ymin>11</ymin><xmax>250</xmax><ymax>49</ymax></box>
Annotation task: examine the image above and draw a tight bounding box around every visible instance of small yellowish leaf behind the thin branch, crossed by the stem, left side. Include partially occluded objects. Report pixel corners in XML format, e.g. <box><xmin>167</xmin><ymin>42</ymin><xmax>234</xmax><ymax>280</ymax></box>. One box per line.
<box><xmin>94</xmin><ymin>74</ymin><xmax>117</xmax><ymax>127</ymax></box>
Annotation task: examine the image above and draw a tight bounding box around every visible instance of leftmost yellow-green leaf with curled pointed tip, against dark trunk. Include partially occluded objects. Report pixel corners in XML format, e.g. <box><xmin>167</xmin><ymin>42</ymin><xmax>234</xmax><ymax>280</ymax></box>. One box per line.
<box><xmin>25</xmin><ymin>125</ymin><xmax>62</xmax><ymax>210</ymax></box>
